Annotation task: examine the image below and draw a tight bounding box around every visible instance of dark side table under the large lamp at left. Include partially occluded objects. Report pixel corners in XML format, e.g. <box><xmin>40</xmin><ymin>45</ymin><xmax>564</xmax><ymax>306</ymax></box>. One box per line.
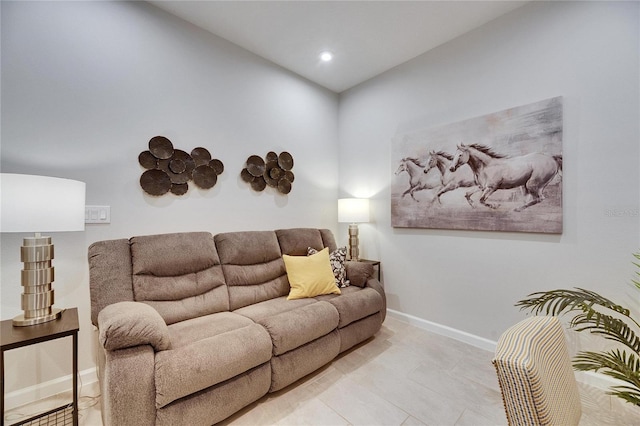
<box><xmin>0</xmin><ymin>308</ymin><xmax>80</xmax><ymax>426</ymax></box>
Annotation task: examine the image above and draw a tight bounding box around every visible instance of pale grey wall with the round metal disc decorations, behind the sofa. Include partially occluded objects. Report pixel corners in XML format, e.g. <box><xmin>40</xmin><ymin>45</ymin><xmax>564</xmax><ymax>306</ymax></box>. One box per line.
<box><xmin>0</xmin><ymin>1</ymin><xmax>338</xmax><ymax>400</ymax></box>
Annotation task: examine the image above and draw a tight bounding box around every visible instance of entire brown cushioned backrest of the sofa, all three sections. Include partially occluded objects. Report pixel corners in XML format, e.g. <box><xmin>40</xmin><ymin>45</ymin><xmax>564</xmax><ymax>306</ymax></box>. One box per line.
<box><xmin>89</xmin><ymin>228</ymin><xmax>336</xmax><ymax>325</ymax></box>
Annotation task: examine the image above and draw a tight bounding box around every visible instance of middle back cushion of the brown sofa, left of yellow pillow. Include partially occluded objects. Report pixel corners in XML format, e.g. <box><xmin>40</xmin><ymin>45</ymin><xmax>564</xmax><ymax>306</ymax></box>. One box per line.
<box><xmin>214</xmin><ymin>231</ymin><xmax>289</xmax><ymax>310</ymax></box>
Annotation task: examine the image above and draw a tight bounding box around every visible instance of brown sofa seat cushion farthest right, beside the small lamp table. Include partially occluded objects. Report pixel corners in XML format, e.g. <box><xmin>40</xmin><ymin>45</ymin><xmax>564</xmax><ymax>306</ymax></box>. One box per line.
<box><xmin>315</xmin><ymin>286</ymin><xmax>383</xmax><ymax>328</ymax></box>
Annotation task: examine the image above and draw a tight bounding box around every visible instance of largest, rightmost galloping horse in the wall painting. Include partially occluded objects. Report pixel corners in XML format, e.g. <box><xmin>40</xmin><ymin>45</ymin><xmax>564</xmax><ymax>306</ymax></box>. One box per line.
<box><xmin>449</xmin><ymin>144</ymin><xmax>562</xmax><ymax>212</ymax></box>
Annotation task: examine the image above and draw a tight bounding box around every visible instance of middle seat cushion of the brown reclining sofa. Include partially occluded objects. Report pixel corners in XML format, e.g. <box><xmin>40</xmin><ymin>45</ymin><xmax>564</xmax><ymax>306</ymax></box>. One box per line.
<box><xmin>258</xmin><ymin>302</ymin><xmax>339</xmax><ymax>356</ymax></box>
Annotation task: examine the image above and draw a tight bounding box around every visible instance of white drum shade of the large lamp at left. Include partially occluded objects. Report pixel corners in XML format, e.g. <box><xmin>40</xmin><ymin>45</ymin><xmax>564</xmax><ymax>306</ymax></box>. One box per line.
<box><xmin>0</xmin><ymin>173</ymin><xmax>85</xmax><ymax>232</ymax></box>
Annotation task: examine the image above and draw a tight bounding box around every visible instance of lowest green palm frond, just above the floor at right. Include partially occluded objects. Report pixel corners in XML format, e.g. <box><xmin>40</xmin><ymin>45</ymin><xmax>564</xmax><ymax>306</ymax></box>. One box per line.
<box><xmin>573</xmin><ymin>349</ymin><xmax>640</xmax><ymax>406</ymax></box>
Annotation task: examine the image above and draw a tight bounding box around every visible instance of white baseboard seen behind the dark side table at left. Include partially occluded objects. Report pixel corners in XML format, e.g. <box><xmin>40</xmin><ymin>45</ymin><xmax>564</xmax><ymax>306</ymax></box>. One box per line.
<box><xmin>4</xmin><ymin>367</ymin><xmax>98</xmax><ymax>410</ymax></box>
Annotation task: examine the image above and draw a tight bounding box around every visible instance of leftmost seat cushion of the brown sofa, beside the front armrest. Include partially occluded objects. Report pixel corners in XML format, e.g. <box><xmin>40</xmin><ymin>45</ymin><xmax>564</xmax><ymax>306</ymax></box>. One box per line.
<box><xmin>155</xmin><ymin>313</ymin><xmax>272</xmax><ymax>408</ymax></box>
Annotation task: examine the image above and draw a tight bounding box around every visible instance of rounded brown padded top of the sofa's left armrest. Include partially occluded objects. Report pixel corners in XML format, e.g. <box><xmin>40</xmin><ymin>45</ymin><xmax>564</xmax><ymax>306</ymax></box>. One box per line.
<box><xmin>98</xmin><ymin>302</ymin><xmax>171</xmax><ymax>351</ymax></box>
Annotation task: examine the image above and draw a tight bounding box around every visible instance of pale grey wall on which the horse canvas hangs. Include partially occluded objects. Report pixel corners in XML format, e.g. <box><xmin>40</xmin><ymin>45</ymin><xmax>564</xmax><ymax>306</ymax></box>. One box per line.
<box><xmin>339</xmin><ymin>2</ymin><xmax>640</xmax><ymax>341</ymax></box>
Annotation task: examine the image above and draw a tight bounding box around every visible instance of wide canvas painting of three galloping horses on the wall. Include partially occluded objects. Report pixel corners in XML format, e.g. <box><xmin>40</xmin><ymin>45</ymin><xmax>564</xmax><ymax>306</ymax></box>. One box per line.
<box><xmin>391</xmin><ymin>97</ymin><xmax>563</xmax><ymax>234</ymax></box>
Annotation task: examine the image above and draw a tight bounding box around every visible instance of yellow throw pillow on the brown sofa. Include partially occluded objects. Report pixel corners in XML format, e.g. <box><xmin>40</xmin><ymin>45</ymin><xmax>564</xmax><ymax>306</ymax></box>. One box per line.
<box><xmin>282</xmin><ymin>248</ymin><xmax>340</xmax><ymax>300</ymax></box>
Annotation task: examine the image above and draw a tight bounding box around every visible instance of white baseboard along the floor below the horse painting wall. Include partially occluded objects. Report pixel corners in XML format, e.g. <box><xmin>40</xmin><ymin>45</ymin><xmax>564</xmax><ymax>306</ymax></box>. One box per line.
<box><xmin>387</xmin><ymin>309</ymin><xmax>622</xmax><ymax>390</ymax></box>
